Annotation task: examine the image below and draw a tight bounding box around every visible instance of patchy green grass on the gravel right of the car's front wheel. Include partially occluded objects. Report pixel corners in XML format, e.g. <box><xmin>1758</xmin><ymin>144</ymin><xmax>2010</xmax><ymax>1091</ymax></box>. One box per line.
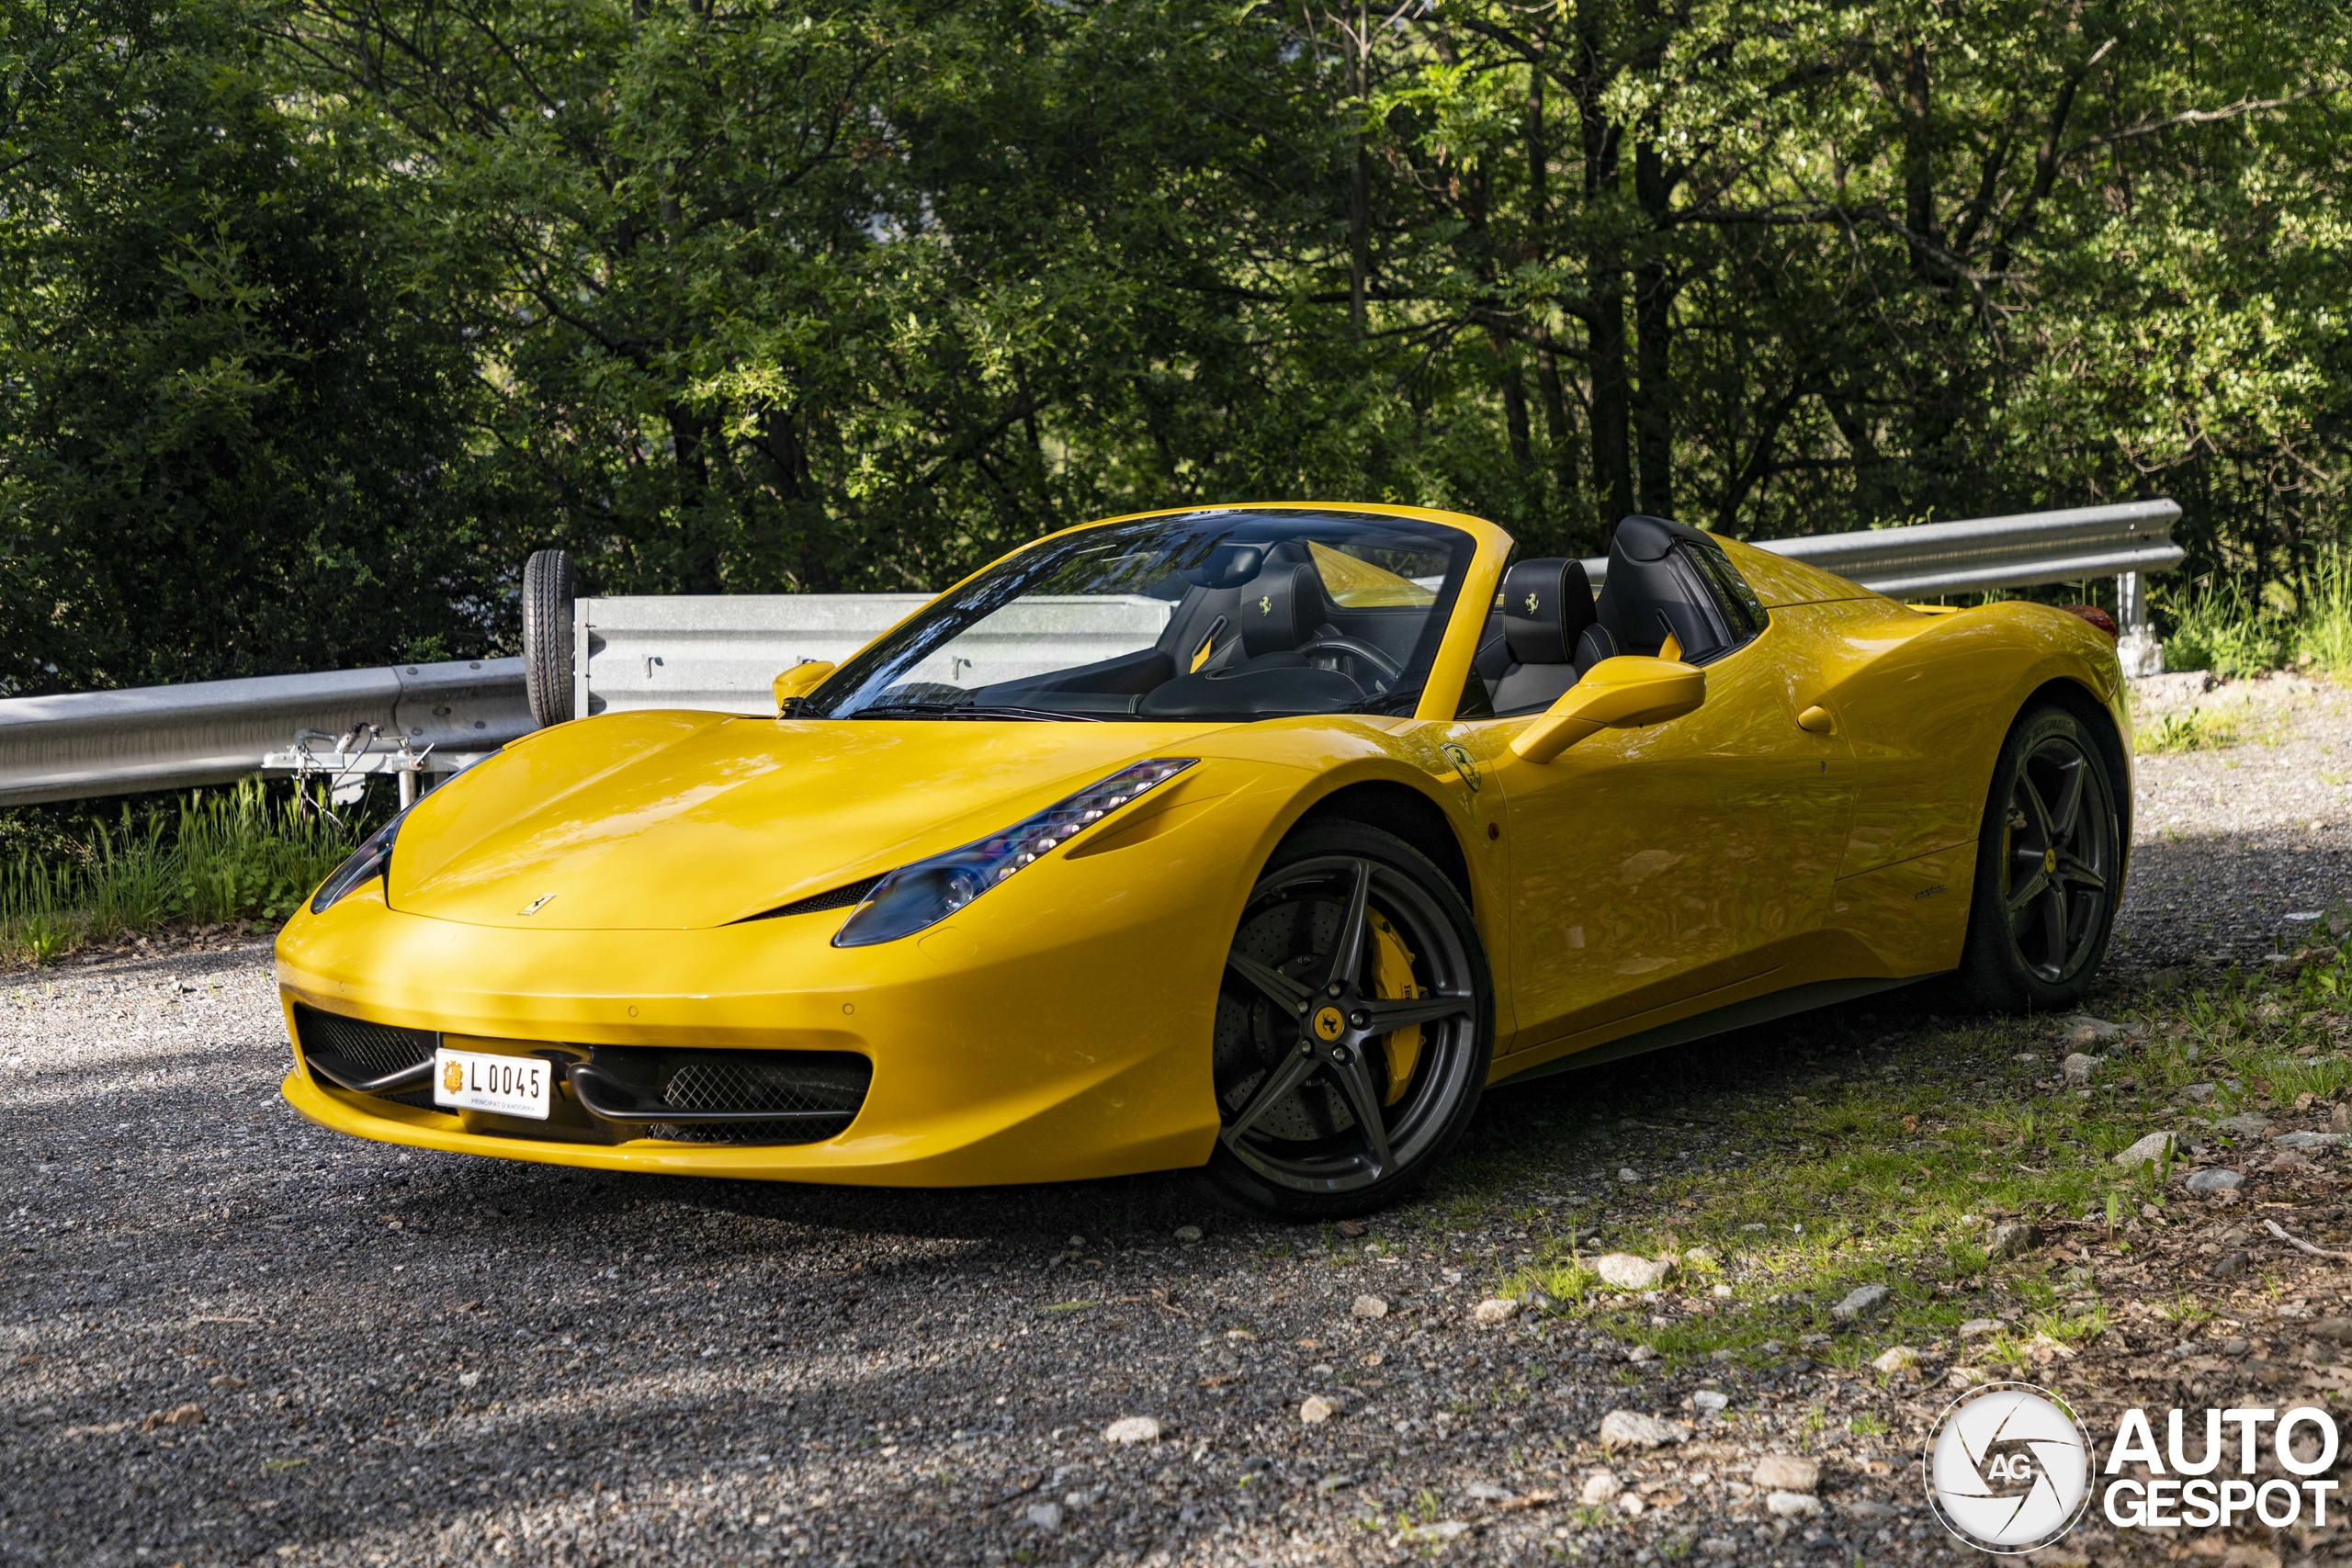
<box><xmin>1430</xmin><ymin>912</ymin><xmax>2352</xmax><ymax>1380</ymax></box>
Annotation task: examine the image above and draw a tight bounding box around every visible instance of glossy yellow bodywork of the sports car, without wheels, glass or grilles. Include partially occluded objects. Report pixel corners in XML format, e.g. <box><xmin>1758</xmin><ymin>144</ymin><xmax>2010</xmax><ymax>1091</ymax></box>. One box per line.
<box><xmin>277</xmin><ymin>505</ymin><xmax>2129</xmax><ymax>1185</ymax></box>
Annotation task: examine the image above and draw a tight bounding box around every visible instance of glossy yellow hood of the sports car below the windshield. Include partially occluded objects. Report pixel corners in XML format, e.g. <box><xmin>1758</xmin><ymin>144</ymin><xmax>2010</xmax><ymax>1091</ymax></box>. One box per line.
<box><xmin>388</xmin><ymin>712</ymin><xmax>1226</xmax><ymax>931</ymax></box>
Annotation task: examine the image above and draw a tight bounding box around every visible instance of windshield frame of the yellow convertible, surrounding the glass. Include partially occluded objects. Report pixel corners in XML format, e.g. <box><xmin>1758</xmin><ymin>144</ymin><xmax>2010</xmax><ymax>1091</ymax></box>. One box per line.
<box><xmin>786</xmin><ymin>503</ymin><xmax>1476</xmax><ymax>724</ymax></box>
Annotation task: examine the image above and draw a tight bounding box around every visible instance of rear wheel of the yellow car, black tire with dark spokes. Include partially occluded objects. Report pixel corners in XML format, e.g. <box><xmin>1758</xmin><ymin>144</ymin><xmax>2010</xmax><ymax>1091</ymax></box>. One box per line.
<box><xmin>1959</xmin><ymin>701</ymin><xmax>2129</xmax><ymax>1013</ymax></box>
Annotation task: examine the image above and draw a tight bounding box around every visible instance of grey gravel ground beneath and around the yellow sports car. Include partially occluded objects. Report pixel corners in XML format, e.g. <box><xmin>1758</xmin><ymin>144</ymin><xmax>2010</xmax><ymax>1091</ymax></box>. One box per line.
<box><xmin>0</xmin><ymin>682</ymin><xmax>2352</xmax><ymax>1565</ymax></box>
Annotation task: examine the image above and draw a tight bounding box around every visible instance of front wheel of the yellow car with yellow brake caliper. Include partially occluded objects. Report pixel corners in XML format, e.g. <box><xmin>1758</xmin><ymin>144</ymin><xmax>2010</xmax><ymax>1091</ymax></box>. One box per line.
<box><xmin>1202</xmin><ymin>823</ymin><xmax>1494</xmax><ymax>1220</ymax></box>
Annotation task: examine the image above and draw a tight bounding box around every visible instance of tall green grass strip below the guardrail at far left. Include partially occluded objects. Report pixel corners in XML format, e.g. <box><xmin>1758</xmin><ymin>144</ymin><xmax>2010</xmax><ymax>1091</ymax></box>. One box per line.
<box><xmin>0</xmin><ymin>783</ymin><xmax>362</xmax><ymax>964</ymax></box>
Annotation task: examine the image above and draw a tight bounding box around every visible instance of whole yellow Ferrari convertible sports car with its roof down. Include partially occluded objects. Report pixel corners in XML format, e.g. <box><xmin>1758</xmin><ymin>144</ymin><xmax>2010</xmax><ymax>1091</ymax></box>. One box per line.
<box><xmin>277</xmin><ymin>505</ymin><xmax>2131</xmax><ymax>1218</ymax></box>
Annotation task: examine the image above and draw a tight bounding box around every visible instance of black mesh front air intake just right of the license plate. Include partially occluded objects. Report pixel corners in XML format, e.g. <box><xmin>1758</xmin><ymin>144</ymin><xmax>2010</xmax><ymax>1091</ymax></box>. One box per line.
<box><xmin>571</xmin><ymin>1046</ymin><xmax>875</xmax><ymax>1143</ymax></box>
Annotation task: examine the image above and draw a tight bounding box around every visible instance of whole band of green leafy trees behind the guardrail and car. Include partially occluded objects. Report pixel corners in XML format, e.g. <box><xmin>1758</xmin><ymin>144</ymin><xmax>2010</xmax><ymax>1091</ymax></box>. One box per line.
<box><xmin>0</xmin><ymin>0</ymin><xmax>2352</xmax><ymax>691</ymax></box>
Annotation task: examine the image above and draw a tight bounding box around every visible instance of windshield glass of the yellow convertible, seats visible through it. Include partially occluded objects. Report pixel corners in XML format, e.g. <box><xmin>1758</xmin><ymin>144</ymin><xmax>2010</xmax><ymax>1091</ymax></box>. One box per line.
<box><xmin>799</xmin><ymin>510</ymin><xmax>1475</xmax><ymax>719</ymax></box>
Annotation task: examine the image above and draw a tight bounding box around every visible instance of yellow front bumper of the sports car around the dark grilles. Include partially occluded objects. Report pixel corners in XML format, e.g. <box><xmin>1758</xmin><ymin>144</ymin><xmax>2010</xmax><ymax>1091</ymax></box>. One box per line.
<box><xmin>277</xmin><ymin>771</ymin><xmax>1284</xmax><ymax>1185</ymax></box>
